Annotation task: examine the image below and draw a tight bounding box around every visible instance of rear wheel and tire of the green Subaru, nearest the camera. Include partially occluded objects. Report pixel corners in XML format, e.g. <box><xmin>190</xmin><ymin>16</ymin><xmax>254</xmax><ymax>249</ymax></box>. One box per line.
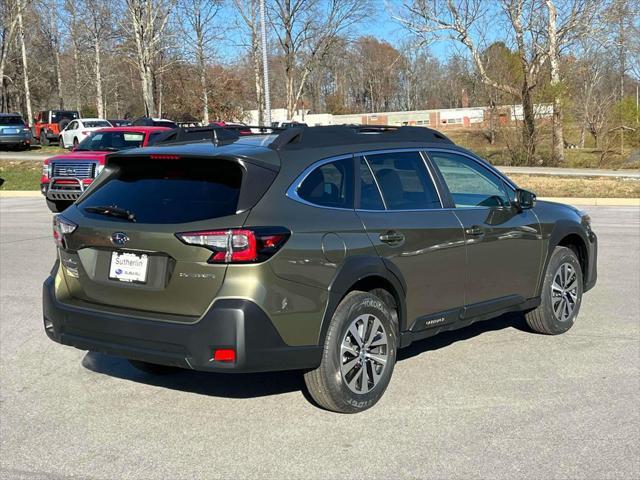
<box><xmin>304</xmin><ymin>292</ymin><xmax>398</xmax><ymax>413</ymax></box>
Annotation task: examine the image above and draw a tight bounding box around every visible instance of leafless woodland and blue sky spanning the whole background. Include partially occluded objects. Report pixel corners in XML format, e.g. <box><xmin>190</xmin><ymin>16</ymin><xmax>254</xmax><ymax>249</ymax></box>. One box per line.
<box><xmin>0</xmin><ymin>0</ymin><xmax>640</xmax><ymax>164</ymax></box>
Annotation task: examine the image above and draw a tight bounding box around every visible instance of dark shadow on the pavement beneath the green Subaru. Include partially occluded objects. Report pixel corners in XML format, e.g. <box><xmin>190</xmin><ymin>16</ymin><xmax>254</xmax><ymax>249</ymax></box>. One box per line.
<box><xmin>82</xmin><ymin>313</ymin><xmax>531</xmax><ymax>403</ymax></box>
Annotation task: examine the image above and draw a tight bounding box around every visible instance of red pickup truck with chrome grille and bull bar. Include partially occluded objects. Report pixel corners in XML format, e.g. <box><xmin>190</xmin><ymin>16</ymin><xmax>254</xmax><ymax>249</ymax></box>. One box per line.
<box><xmin>40</xmin><ymin>126</ymin><xmax>170</xmax><ymax>212</ymax></box>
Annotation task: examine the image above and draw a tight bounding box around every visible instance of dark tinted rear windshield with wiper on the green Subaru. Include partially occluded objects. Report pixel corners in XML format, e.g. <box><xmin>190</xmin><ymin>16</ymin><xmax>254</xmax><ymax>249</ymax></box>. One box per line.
<box><xmin>79</xmin><ymin>159</ymin><xmax>243</xmax><ymax>223</ymax></box>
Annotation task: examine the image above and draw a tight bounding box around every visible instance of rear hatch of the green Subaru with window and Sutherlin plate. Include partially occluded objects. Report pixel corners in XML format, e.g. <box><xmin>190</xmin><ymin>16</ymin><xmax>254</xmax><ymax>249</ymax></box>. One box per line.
<box><xmin>61</xmin><ymin>155</ymin><xmax>277</xmax><ymax>317</ymax></box>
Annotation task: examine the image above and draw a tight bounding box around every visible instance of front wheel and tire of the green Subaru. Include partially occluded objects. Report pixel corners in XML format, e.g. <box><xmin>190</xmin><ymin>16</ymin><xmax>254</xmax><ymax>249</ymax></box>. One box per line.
<box><xmin>525</xmin><ymin>247</ymin><xmax>584</xmax><ymax>335</ymax></box>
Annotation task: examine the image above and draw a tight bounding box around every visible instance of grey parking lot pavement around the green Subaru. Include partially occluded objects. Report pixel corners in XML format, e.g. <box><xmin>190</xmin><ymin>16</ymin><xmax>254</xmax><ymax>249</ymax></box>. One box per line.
<box><xmin>0</xmin><ymin>198</ymin><xmax>640</xmax><ymax>479</ymax></box>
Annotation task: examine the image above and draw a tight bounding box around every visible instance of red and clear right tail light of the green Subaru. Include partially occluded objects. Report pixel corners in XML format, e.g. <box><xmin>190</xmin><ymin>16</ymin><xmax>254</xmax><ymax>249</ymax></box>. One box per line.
<box><xmin>176</xmin><ymin>227</ymin><xmax>291</xmax><ymax>263</ymax></box>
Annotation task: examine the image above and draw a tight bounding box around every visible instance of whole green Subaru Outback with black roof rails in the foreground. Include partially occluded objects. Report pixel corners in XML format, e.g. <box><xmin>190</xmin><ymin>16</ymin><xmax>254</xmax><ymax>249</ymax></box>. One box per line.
<box><xmin>43</xmin><ymin>126</ymin><xmax>597</xmax><ymax>412</ymax></box>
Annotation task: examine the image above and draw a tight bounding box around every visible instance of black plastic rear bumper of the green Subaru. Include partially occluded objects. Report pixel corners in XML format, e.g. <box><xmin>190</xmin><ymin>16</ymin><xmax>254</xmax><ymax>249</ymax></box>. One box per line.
<box><xmin>43</xmin><ymin>277</ymin><xmax>322</xmax><ymax>372</ymax></box>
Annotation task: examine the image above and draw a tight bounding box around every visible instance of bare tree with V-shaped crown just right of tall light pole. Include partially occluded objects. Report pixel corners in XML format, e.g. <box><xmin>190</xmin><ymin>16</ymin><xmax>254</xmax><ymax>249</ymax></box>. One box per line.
<box><xmin>271</xmin><ymin>0</ymin><xmax>370</xmax><ymax>118</ymax></box>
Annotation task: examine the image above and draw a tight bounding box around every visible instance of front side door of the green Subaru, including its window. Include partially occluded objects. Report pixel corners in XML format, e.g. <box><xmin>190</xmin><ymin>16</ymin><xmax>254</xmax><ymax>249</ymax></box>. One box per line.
<box><xmin>428</xmin><ymin>150</ymin><xmax>543</xmax><ymax>310</ymax></box>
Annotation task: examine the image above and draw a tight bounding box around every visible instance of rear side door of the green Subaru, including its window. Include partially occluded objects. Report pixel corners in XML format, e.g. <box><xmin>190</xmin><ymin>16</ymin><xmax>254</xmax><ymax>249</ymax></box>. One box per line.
<box><xmin>357</xmin><ymin>151</ymin><xmax>465</xmax><ymax>329</ymax></box>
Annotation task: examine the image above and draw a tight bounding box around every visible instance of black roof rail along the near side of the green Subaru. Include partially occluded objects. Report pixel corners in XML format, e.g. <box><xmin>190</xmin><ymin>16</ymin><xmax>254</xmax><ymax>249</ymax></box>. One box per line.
<box><xmin>269</xmin><ymin>125</ymin><xmax>453</xmax><ymax>150</ymax></box>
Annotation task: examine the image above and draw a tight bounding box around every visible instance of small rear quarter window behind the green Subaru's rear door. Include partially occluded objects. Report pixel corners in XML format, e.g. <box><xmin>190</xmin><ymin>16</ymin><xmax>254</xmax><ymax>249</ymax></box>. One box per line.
<box><xmin>298</xmin><ymin>158</ymin><xmax>353</xmax><ymax>208</ymax></box>
